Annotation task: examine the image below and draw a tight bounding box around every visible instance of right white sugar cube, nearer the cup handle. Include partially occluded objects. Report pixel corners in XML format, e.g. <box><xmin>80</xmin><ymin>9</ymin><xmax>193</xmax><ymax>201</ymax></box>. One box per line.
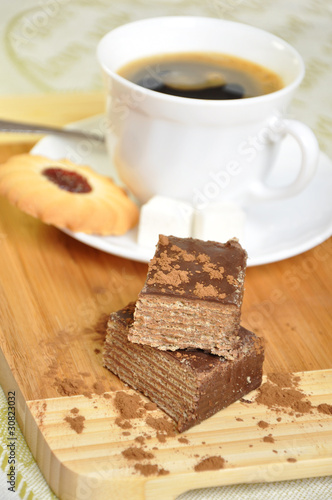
<box><xmin>193</xmin><ymin>201</ymin><xmax>246</xmax><ymax>243</ymax></box>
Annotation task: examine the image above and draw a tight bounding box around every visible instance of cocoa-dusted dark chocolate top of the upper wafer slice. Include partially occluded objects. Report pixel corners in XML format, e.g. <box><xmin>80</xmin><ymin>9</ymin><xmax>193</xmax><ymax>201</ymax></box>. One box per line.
<box><xmin>141</xmin><ymin>235</ymin><xmax>247</xmax><ymax>304</ymax></box>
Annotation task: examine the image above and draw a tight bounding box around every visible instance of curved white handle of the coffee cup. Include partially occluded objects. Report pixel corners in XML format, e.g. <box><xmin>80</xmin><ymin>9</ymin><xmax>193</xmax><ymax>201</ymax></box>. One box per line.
<box><xmin>252</xmin><ymin>119</ymin><xmax>319</xmax><ymax>200</ymax></box>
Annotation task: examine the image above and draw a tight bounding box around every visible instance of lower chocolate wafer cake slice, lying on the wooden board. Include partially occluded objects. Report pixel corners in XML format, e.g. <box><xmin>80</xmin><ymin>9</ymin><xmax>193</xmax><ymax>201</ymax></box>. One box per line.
<box><xmin>103</xmin><ymin>303</ymin><xmax>264</xmax><ymax>432</ymax></box>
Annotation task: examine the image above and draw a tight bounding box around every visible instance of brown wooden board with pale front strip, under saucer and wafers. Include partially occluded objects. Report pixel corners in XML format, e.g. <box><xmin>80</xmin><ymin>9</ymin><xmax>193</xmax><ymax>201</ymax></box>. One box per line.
<box><xmin>0</xmin><ymin>95</ymin><xmax>332</xmax><ymax>500</ymax></box>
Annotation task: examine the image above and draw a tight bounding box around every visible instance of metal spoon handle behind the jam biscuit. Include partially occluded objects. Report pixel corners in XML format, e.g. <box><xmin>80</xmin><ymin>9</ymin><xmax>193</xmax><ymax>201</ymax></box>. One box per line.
<box><xmin>0</xmin><ymin>120</ymin><xmax>105</xmax><ymax>142</ymax></box>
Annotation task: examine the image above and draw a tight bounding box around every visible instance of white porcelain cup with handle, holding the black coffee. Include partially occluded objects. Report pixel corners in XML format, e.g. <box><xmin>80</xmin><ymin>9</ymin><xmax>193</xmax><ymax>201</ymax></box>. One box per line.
<box><xmin>98</xmin><ymin>16</ymin><xmax>319</xmax><ymax>206</ymax></box>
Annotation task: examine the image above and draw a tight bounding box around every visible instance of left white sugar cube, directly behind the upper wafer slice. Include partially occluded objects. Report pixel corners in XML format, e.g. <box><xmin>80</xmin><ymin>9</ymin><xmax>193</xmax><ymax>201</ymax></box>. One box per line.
<box><xmin>138</xmin><ymin>195</ymin><xmax>194</xmax><ymax>248</ymax></box>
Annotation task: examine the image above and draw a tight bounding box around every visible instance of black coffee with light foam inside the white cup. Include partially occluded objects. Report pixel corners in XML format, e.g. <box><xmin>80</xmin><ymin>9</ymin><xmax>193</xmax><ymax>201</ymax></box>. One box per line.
<box><xmin>118</xmin><ymin>52</ymin><xmax>283</xmax><ymax>100</ymax></box>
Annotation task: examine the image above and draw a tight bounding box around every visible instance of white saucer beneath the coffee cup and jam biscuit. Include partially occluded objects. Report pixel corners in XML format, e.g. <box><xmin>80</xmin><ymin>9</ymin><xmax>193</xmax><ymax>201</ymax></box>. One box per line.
<box><xmin>32</xmin><ymin>116</ymin><xmax>332</xmax><ymax>266</ymax></box>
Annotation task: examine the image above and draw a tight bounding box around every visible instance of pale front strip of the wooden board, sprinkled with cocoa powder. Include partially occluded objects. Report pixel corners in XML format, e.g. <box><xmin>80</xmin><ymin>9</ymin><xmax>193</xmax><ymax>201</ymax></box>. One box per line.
<box><xmin>0</xmin><ymin>348</ymin><xmax>332</xmax><ymax>500</ymax></box>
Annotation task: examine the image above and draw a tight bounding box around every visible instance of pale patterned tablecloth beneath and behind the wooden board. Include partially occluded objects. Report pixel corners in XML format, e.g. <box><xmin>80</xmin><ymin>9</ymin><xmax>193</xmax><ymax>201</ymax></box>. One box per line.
<box><xmin>0</xmin><ymin>0</ymin><xmax>332</xmax><ymax>500</ymax></box>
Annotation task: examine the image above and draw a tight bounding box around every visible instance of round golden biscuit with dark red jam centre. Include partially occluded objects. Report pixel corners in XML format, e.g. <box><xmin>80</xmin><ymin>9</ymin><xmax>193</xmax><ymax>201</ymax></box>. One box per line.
<box><xmin>0</xmin><ymin>154</ymin><xmax>139</xmax><ymax>236</ymax></box>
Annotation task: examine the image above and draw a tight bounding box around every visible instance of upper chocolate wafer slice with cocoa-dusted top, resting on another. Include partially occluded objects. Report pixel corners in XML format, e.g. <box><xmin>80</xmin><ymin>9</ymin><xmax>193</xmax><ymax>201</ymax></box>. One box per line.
<box><xmin>129</xmin><ymin>235</ymin><xmax>247</xmax><ymax>359</ymax></box>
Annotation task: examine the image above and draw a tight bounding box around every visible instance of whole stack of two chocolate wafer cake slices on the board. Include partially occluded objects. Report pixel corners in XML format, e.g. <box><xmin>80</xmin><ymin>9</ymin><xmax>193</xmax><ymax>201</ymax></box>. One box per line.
<box><xmin>103</xmin><ymin>235</ymin><xmax>264</xmax><ymax>431</ymax></box>
